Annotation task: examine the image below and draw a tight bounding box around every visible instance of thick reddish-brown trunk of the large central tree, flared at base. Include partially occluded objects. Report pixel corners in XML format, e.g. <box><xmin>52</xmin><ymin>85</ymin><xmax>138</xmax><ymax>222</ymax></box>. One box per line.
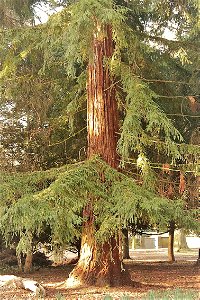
<box><xmin>67</xmin><ymin>24</ymin><xmax>121</xmax><ymax>286</ymax></box>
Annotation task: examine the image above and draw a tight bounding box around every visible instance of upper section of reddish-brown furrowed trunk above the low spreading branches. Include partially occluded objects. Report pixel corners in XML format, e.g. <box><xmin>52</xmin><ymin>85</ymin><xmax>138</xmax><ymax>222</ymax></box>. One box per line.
<box><xmin>87</xmin><ymin>22</ymin><xmax>118</xmax><ymax>168</ymax></box>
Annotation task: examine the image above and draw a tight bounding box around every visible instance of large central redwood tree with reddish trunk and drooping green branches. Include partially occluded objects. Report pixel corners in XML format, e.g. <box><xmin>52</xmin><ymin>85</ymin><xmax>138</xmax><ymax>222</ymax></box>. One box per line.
<box><xmin>0</xmin><ymin>0</ymin><xmax>197</xmax><ymax>286</ymax></box>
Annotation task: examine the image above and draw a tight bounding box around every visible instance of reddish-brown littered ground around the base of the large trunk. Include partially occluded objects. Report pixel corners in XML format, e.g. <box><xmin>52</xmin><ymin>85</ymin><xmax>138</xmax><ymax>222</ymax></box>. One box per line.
<box><xmin>0</xmin><ymin>250</ymin><xmax>200</xmax><ymax>300</ymax></box>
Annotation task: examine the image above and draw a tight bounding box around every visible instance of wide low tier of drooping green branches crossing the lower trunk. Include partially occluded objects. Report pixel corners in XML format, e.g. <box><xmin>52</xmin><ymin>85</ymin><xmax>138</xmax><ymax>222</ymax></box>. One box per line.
<box><xmin>0</xmin><ymin>158</ymin><xmax>198</xmax><ymax>251</ymax></box>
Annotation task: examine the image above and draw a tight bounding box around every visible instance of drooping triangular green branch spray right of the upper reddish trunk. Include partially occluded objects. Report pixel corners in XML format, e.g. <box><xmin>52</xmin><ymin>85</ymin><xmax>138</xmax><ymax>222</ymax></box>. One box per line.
<box><xmin>119</xmin><ymin>67</ymin><xmax>183</xmax><ymax>158</ymax></box>
